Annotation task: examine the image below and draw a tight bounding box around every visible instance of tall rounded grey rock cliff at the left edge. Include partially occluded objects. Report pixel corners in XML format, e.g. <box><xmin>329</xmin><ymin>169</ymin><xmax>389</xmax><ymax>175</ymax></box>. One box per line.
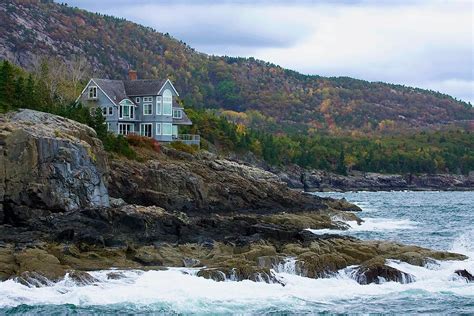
<box><xmin>0</xmin><ymin>110</ymin><xmax>109</xmax><ymax>223</ymax></box>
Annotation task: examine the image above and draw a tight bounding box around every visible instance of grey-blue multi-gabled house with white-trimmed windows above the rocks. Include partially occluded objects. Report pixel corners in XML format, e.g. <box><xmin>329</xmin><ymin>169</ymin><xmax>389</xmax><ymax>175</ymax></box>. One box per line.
<box><xmin>77</xmin><ymin>70</ymin><xmax>200</xmax><ymax>145</ymax></box>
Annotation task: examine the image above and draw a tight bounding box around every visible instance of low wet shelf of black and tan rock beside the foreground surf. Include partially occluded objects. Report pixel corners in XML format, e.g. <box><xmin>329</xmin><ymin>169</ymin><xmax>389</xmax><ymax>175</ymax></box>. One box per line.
<box><xmin>0</xmin><ymin>205</ymin><xmax>465</xmax><ymax>284</ymax></box>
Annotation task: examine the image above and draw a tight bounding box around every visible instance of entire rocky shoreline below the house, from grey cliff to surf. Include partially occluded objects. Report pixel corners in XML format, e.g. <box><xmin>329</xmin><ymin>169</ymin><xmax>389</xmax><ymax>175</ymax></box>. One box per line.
<box><xmin>0</xmin><ymin>110</ymin><xmax>466</xmax><ymax>286</ymax></box>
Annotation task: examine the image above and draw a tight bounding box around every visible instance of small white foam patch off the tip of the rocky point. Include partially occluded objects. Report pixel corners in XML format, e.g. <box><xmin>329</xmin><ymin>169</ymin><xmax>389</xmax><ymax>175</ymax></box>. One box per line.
<box><xmin>308</xmin><ymin>218</ymin><xmax>417</xmax><ymax>235</ymax></box>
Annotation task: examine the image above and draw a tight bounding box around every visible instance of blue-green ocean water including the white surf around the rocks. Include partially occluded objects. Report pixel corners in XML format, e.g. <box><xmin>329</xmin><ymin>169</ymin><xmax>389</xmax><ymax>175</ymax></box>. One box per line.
<box><xmin>0</xmin><ymin>192</ymin><xmax>474</xmax><ymax>315</ymax></box>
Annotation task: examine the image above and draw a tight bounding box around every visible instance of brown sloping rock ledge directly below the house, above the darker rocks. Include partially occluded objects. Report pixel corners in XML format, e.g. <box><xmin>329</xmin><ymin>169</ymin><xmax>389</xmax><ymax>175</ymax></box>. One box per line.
<box><xmin>109</xmin><ymin>149</ymin><xmax>336</xmax><ymax>213</ymax></box>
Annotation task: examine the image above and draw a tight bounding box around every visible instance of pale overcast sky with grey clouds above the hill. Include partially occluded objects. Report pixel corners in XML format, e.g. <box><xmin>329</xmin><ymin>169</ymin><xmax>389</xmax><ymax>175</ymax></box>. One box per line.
<box><xmin>66</xmin><ymin>0</ymin><xmax>474</xmax><ymax>103</ymax></box>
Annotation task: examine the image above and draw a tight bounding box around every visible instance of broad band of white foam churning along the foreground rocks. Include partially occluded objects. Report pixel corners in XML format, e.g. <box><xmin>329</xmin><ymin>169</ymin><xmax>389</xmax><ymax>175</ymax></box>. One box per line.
<box><xmin>0</xmin><ymin>242</ymin><xmax>474</xmax><ymax>313</ymax></box>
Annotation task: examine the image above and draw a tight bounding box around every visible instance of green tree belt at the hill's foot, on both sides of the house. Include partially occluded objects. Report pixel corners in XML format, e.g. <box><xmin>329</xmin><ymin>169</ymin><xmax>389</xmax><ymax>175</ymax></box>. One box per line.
<box><xmin>0</xmin><ymin>59</ymin><xmax>474</xmax><ymax>174</ymax></box>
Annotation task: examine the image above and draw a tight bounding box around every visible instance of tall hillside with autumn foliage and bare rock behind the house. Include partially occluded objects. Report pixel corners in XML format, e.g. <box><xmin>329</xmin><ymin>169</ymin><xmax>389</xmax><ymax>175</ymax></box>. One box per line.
<box><xmin>0</xmin><ymin>0</ymin><xmax>474</xmax><ymax>135</ymax></box>
